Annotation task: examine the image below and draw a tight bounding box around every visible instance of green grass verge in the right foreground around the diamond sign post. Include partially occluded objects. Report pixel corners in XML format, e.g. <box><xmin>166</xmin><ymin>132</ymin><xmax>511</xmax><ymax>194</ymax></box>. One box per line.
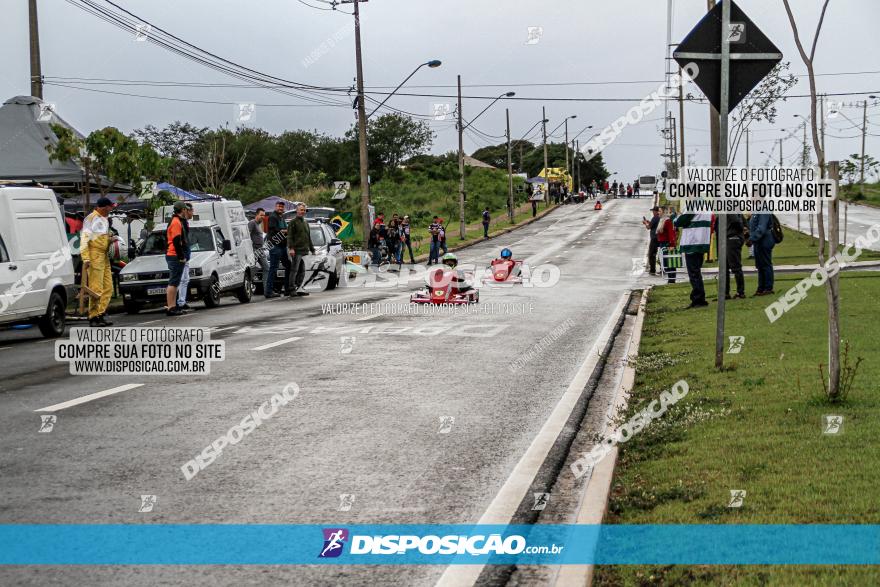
<box><xmin>595</xmin><ymin>272</ymin><xmax>880</xmax><ymax>586</ymax></box>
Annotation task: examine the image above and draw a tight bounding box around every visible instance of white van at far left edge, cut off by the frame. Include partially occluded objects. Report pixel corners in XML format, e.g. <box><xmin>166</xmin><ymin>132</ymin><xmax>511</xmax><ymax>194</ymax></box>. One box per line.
<box><xmin>0</xmin><ymin>185</ymin><xmax>75</xmax><ymax>337</ymax></box>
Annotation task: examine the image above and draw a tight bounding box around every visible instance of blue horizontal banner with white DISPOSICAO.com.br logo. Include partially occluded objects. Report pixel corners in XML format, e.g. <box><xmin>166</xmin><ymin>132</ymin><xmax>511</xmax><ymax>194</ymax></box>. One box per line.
<box><xmin>0</xmin><ymin>524</ymin><xmax>880</xmax><ymax>565</ymax></box>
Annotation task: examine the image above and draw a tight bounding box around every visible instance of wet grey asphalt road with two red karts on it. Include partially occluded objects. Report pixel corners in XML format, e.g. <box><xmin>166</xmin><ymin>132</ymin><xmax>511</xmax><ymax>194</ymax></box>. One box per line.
<box><xmin>0</xmin><ymin>198</ymin><xmax>661</xmax><ymax>585</ymax></box>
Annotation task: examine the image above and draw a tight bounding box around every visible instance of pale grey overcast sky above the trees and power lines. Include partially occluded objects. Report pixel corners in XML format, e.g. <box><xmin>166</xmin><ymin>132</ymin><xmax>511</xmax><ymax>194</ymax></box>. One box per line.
<box><xmin>0</xmin><ymin>0</ymin><xmax>880</xmax><ymax>179</ymax></box>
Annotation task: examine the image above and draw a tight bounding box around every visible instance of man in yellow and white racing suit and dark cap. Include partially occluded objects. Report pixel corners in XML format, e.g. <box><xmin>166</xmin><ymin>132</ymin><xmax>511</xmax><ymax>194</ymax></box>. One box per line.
<box><xmin>80</xmin><ymin>197</ymin><xmax>115</xmax><ymax>327</ymax></box>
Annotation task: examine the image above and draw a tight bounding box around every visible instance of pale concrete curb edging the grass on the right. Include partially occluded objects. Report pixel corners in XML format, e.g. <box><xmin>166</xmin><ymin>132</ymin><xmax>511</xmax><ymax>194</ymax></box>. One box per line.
<box><xmin>555</xmin><ymin>286</ymin><xmax>651</xmax><ymax>587</ymax></box>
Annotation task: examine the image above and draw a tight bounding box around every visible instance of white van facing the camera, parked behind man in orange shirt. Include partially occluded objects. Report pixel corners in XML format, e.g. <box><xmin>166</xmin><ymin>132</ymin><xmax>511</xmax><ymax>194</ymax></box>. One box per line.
<box><xmin>119</xmin><ymin>200</ymin><xmax>256</xmax><ymax>314</ymax></box>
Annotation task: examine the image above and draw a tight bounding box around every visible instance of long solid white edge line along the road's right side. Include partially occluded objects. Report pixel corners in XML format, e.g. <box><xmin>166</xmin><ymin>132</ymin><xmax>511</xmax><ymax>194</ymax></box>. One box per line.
<box><xmin>436</xmin><ymin>293</ymin><xmax>629</xmax><ymax>587</ymax></box>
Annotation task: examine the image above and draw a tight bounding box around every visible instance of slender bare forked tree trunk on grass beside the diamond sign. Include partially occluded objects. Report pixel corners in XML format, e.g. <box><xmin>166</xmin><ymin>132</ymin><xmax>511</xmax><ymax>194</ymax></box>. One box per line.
<box><xmin>782</xmin><ymin>0</ymin><xmax>840</xmax><ymax>401</ymax></box>
